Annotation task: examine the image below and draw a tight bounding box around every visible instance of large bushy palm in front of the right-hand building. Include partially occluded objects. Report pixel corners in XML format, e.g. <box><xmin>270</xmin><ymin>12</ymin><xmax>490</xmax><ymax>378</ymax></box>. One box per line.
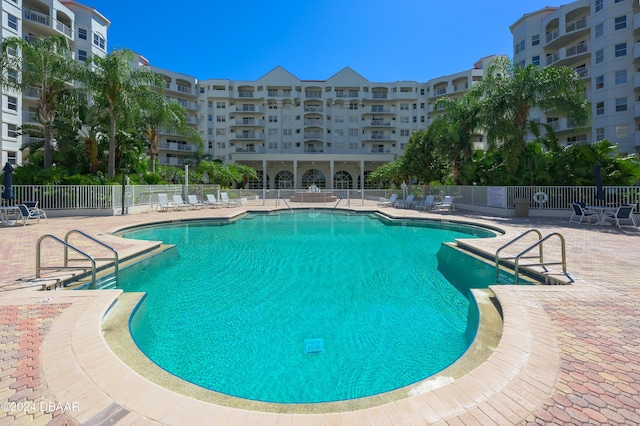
<box><xmin>473</xmin><ymin>57</ymin><xmax>591</xmax><ymax>173</ymax></box>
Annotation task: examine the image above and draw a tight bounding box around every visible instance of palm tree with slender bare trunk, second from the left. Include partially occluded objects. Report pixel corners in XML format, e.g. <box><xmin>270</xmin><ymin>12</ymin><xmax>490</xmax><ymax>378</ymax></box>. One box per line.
<box><xmin>85</xmin><ymin>49</ymin><xmax>163</xmax><ymax>177</ymax></box>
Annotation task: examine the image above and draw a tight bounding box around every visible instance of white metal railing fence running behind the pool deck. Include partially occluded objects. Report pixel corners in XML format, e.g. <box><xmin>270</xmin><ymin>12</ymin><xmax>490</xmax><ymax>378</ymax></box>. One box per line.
<box><xmin>2</xmin><ymin>185</ymin><xmax>640</xmax><ymax>216</ymax></box>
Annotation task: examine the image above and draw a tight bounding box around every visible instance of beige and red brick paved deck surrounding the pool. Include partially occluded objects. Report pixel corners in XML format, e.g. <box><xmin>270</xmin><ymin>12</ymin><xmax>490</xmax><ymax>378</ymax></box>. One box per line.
<box><xmin>0</xmin><ymin>202</ymin><xmax>640</xmax><ymax>426</ymax></box>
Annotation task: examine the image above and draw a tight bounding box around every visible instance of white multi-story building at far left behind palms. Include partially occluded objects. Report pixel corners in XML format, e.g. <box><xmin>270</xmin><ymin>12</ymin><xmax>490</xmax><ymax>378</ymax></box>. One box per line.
<box><xmin>0</xmin><ymin>0</ymin><xmax>110</xmax><ymax>164</ymax></box>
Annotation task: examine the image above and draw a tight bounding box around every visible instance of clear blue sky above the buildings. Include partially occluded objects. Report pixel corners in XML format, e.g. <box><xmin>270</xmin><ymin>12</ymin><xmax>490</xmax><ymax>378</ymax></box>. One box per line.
<box><xmin>80</xmin><ymin>0</ymin><xmax>561</xmax><ymax>82</ymax></box>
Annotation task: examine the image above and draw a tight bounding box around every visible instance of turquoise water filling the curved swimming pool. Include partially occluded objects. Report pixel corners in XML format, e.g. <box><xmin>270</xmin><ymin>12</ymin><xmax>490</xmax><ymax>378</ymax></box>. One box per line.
<box><xmin>118</xmin><ymin>211</ymin><xmax>494</xmax><ymax>403</ymax></box>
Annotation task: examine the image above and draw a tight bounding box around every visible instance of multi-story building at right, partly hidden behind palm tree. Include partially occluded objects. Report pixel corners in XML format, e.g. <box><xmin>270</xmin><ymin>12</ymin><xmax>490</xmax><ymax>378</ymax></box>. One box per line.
<box><xmin>511</xmin><ymin>0</ymin><xmax>640</xmax><ymax>153</ymax></box>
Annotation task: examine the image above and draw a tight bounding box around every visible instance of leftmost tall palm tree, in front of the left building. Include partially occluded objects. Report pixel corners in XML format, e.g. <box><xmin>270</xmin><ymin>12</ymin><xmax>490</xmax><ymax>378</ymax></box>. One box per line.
<box><xmin>0</xmin><ymin>35</ymin><xmax>80</xmax><ymax>167</ymax></box>
